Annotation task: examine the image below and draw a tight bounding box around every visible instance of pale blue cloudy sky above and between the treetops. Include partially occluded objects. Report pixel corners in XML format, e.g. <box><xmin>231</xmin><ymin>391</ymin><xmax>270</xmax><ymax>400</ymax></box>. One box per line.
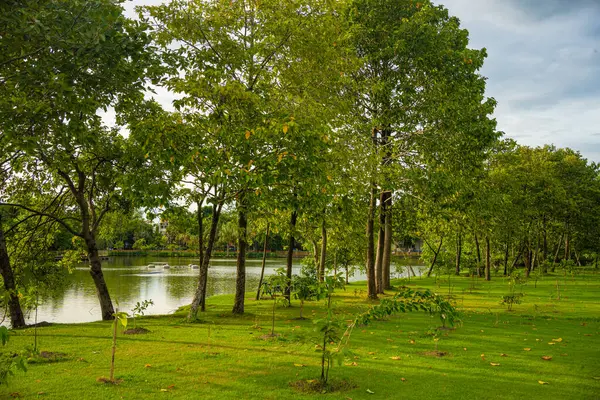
<box><xmin>126</xmin><ymin>0</ymin><xmax>600</xmax><ymax>162</ymax></box>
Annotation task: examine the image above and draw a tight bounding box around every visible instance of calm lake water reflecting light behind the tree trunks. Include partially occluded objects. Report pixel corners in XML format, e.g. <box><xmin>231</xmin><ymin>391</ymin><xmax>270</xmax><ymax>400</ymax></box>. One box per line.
<box><xmin>28</xmin><ymin>257</ymin><xmax>418</xmax><ymax>323</ymax></box>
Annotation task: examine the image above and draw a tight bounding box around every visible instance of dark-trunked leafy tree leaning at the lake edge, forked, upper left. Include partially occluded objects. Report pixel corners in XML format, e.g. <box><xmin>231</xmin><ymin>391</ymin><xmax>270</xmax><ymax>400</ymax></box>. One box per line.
<box><xmin>0</xmin><ymin>0</ymin><xmax>151</xmax><ymax>319</ymax></box>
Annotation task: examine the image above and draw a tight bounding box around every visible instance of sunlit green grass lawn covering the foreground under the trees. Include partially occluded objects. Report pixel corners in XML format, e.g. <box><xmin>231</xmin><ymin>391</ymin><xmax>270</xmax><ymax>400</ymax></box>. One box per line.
<box><xmin>0</xmin><ymin>270</ymin><xmax>600</xmax><ymax>400</ymax></box>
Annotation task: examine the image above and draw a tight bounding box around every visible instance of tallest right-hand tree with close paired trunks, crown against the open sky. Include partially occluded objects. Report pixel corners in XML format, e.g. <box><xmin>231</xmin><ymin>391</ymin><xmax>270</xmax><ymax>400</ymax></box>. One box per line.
<box><xmin>347</xmin><ymin>0</ymin><xmax>497</xmax><ymax>298</ymax></box>
